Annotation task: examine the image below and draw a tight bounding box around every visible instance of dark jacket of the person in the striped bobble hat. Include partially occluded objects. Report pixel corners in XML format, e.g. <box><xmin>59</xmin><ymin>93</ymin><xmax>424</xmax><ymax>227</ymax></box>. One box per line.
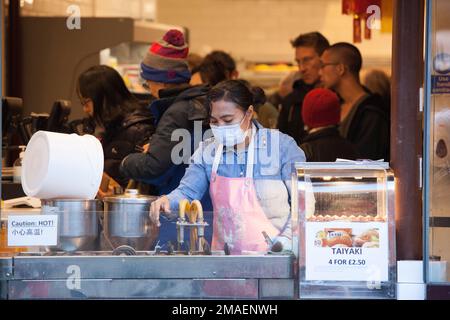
<box><xmin>121</xmin><ymin>85</ymin><xmax>209</xmax><ymax>181</ymax></box>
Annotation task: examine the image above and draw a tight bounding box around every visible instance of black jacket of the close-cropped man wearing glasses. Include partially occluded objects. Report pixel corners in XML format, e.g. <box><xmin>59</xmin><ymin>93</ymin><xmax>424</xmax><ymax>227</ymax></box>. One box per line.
<box><xmin>340</xmin><ymin>94</ymin><xmax>390</xmax><ymax>161</ymax></box>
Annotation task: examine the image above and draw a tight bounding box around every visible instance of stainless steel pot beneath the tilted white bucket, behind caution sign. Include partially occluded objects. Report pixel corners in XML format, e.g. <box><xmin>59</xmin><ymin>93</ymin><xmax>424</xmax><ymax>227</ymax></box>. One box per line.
<box><xmin>41</xmin><ymin>199</ymin><xmax>103</xmax><ymax>251</ymax></box>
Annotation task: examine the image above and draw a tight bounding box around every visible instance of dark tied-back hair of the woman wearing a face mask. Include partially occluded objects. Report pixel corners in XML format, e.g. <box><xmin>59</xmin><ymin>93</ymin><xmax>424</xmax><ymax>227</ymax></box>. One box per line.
<box><xmin>207</xmin><ymin>80</ymin><xmax>266</xmax><ymax>111</ymax></box>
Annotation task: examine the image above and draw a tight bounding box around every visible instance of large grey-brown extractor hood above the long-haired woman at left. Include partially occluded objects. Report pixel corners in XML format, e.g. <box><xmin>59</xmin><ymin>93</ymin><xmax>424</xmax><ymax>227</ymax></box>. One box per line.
<box><xmin>20</xmin><ymin>17</ymin><xmax>189</xmax><ymax>119</ymax></box>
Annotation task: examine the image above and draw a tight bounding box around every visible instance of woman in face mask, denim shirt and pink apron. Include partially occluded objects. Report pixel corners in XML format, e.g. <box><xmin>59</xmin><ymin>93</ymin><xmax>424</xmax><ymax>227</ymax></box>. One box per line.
<box><xmin>150</xmin><ymin>80</ymin><xmax>306</xmax><ymax>254</ymax></box>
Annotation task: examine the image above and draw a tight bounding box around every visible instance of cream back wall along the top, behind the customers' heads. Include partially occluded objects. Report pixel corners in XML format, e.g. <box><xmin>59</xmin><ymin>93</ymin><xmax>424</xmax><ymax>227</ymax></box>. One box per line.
<box><xmin>22</xmin><ymin>0</ymin><xmax>391</xmax><ymax>68</ymax></box>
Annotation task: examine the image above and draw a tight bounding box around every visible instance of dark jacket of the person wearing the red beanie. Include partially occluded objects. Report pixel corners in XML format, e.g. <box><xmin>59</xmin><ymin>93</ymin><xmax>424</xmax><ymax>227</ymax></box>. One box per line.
<box><xmin>300</xmin><ymin>127</ymin><xmax>359</xmax><ymax>162</ymax></box>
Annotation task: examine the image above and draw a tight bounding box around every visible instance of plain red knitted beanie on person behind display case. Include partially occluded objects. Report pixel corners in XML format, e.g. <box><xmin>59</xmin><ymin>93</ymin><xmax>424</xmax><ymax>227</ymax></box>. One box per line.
<box><xmin>302</xmin><ymin>88</ymin><xmax>341</xmax><ymax>129</ymax></box>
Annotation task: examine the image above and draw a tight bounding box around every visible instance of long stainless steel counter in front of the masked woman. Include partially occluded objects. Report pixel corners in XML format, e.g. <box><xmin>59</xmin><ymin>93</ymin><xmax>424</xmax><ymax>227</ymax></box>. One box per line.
<box><xmin>0</xmin><ymin>252</ymin><xmax>295</xmax><ymax>299</ymax></box>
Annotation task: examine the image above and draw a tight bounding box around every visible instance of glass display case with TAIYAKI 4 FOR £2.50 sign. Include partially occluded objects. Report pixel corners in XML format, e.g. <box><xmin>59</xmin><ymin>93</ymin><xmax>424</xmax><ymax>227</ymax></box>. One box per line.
<box><xmin>292</xmin><ymin>161</ymin><xmax>396</xmax><ymax>299</ymax></box>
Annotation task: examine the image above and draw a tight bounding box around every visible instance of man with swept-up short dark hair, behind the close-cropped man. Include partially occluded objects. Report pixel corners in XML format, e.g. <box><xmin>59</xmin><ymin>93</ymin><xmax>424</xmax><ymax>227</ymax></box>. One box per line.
<box><xmin>278</xmin><ymin>32</ymin><xmax>329</xmax><ymax>144</ymax></box>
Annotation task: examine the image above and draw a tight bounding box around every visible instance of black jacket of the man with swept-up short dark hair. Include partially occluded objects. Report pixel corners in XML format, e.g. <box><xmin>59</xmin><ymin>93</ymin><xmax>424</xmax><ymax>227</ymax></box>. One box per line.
<box><xmin>278</xmin><ymin>80</ymin><xmax>315</xmax><ymax>144</ymax></box>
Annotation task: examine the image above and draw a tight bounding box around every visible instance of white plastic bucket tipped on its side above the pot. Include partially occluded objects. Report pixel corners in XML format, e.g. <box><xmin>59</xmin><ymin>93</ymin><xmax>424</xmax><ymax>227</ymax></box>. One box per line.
<box><xmin>22</xmin><ymin>131</ymin><xmax>103</xmax><ymax>199</ymax></box>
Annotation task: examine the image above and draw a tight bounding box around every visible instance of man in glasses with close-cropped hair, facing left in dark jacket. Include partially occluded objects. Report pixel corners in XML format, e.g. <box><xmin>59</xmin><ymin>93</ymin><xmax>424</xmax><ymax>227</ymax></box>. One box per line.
<box><xmin>320</xmin><ymin>42</ymin><xmax>390</xmax><ymax>161</ymax></box>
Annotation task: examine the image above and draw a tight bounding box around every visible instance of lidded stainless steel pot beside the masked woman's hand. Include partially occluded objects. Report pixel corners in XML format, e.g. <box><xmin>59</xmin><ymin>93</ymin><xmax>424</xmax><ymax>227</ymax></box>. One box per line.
<box><xmin>103</xmin><ymin>189</ymin><xmax>159</xmax><ymax>250</ymax></box>
